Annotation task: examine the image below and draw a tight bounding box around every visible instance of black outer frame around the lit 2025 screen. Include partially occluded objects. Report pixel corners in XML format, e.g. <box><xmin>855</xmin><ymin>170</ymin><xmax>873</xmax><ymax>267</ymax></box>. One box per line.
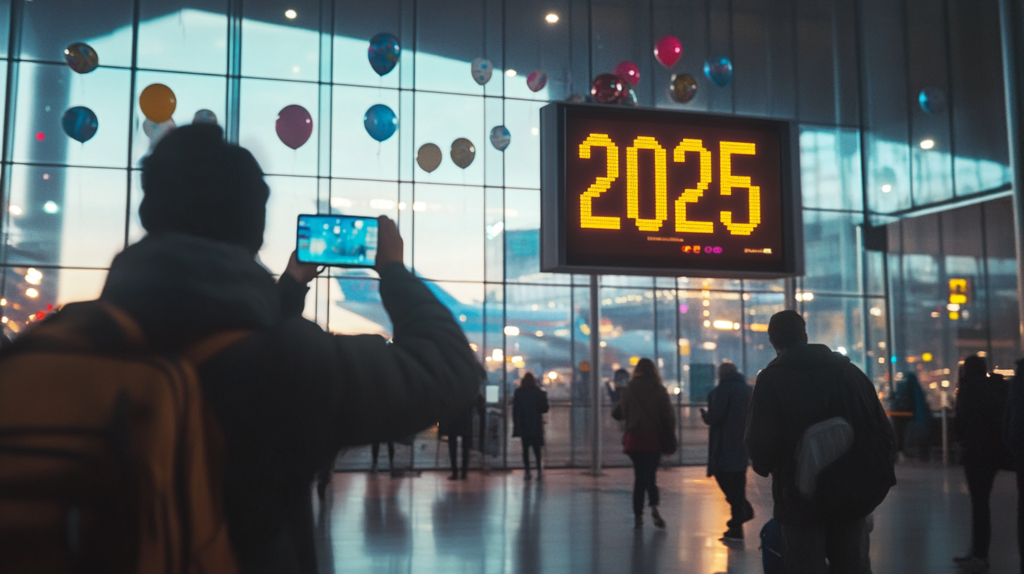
<box><xmin>541</xmin><ymin>102</ymin><xmax>804</xmax><ymax>279</ymax></box>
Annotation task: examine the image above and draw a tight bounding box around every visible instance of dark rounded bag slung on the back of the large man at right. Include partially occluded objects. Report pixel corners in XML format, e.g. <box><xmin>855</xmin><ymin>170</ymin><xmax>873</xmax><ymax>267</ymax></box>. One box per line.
<box><xmin>810</xmin><ymin>364</ymin><xmax>896</xmax><ymax>522</ymax></box>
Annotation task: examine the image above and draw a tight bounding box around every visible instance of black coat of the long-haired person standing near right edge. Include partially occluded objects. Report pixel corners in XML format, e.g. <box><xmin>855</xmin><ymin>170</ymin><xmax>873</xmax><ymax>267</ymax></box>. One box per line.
<box><xmin>953</xmin><ymin>374</ymin><xmax>1010</xmax><ymax>469</ymax></box>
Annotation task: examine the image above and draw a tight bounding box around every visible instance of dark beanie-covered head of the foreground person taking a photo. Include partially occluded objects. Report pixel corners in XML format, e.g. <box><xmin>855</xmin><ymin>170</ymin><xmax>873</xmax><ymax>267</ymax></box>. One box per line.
<box><xmin>138</xmin><ymin>124</ymin><xmax>270</xmax><ymax>254</ymax></box>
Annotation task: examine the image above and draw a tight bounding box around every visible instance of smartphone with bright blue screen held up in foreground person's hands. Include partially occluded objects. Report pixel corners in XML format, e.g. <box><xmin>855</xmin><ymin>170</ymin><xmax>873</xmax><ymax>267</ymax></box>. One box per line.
<box><xmin>295</xmin><ymin>215</ymin><xmax>377</xmax><ymax>267</ymax></box>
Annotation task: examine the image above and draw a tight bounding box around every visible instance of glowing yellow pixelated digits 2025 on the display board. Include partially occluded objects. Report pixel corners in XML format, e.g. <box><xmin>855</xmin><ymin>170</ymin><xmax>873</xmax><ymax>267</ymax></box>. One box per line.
<box><xmin>580</xmin><ymin>134</ymin><xmax>761</xmax><ymax>235</ymax></box>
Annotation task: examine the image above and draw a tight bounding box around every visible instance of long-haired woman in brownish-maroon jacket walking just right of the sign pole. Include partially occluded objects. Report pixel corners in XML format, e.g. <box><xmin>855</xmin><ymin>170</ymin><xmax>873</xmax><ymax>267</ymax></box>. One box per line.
<box><xmin>611</xmin><ymin>359</ymin><xmax>676</xmax><ymax>528</ymax></box>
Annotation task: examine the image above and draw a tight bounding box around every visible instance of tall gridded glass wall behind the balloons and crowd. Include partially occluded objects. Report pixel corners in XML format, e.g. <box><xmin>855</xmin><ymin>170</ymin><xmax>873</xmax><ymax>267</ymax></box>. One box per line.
<box><xmin>0</xmin><ymin>0</ymin><xmax>1007</xmax><ymax>469</ymax></box>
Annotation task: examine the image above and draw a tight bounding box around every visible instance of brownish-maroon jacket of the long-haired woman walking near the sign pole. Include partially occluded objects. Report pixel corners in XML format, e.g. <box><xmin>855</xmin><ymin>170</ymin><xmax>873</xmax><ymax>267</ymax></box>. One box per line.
<box><xmin>611</xmin><ymin>379</ymin><xmax>676</xmax><ymax>453</ymax></box>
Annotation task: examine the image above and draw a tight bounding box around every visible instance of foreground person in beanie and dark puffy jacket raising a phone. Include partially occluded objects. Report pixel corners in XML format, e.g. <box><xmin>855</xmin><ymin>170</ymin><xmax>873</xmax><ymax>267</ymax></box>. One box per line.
<box><xmin>101</xmin><ymin>125</ymin><xmax>476</xmax><ymax>574</ymax></box>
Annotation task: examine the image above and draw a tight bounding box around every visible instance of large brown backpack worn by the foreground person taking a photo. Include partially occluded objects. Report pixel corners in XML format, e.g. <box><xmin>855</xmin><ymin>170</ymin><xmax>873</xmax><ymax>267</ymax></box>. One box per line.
<box><xmin>0</xmin><ymin>302</ymin><xmax>246</xmax><ymax>574</ymax></box>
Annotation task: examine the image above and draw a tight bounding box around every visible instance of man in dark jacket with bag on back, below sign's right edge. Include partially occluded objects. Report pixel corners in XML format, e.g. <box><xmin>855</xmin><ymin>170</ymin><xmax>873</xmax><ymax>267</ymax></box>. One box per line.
<box><xmin>744</xmin><ymin>311</ymin><xmax>896</xmax><ymax>574</ymax></box>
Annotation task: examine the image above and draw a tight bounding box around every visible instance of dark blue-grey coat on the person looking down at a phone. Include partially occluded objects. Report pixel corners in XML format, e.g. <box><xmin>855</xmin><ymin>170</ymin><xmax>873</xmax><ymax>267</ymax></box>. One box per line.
<box><xmin>703</xmin><ymin>372</ymin><xmax>754</xmax><ymax>476</ymax></box>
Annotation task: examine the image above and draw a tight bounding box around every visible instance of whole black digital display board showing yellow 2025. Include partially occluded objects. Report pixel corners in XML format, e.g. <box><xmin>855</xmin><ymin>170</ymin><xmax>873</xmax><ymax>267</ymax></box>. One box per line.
<box><xmin>541</xmin><ymin>102</ymin><xmax>803</xmax><ymax>278</ymax></box>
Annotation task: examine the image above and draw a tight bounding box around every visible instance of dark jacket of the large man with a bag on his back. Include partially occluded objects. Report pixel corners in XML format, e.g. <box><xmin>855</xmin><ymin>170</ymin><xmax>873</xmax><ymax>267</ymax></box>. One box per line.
<box><xmin>743</xmin><ymin>345</ymin><xmax>896</xmax><ymax>525</ymax></box>
